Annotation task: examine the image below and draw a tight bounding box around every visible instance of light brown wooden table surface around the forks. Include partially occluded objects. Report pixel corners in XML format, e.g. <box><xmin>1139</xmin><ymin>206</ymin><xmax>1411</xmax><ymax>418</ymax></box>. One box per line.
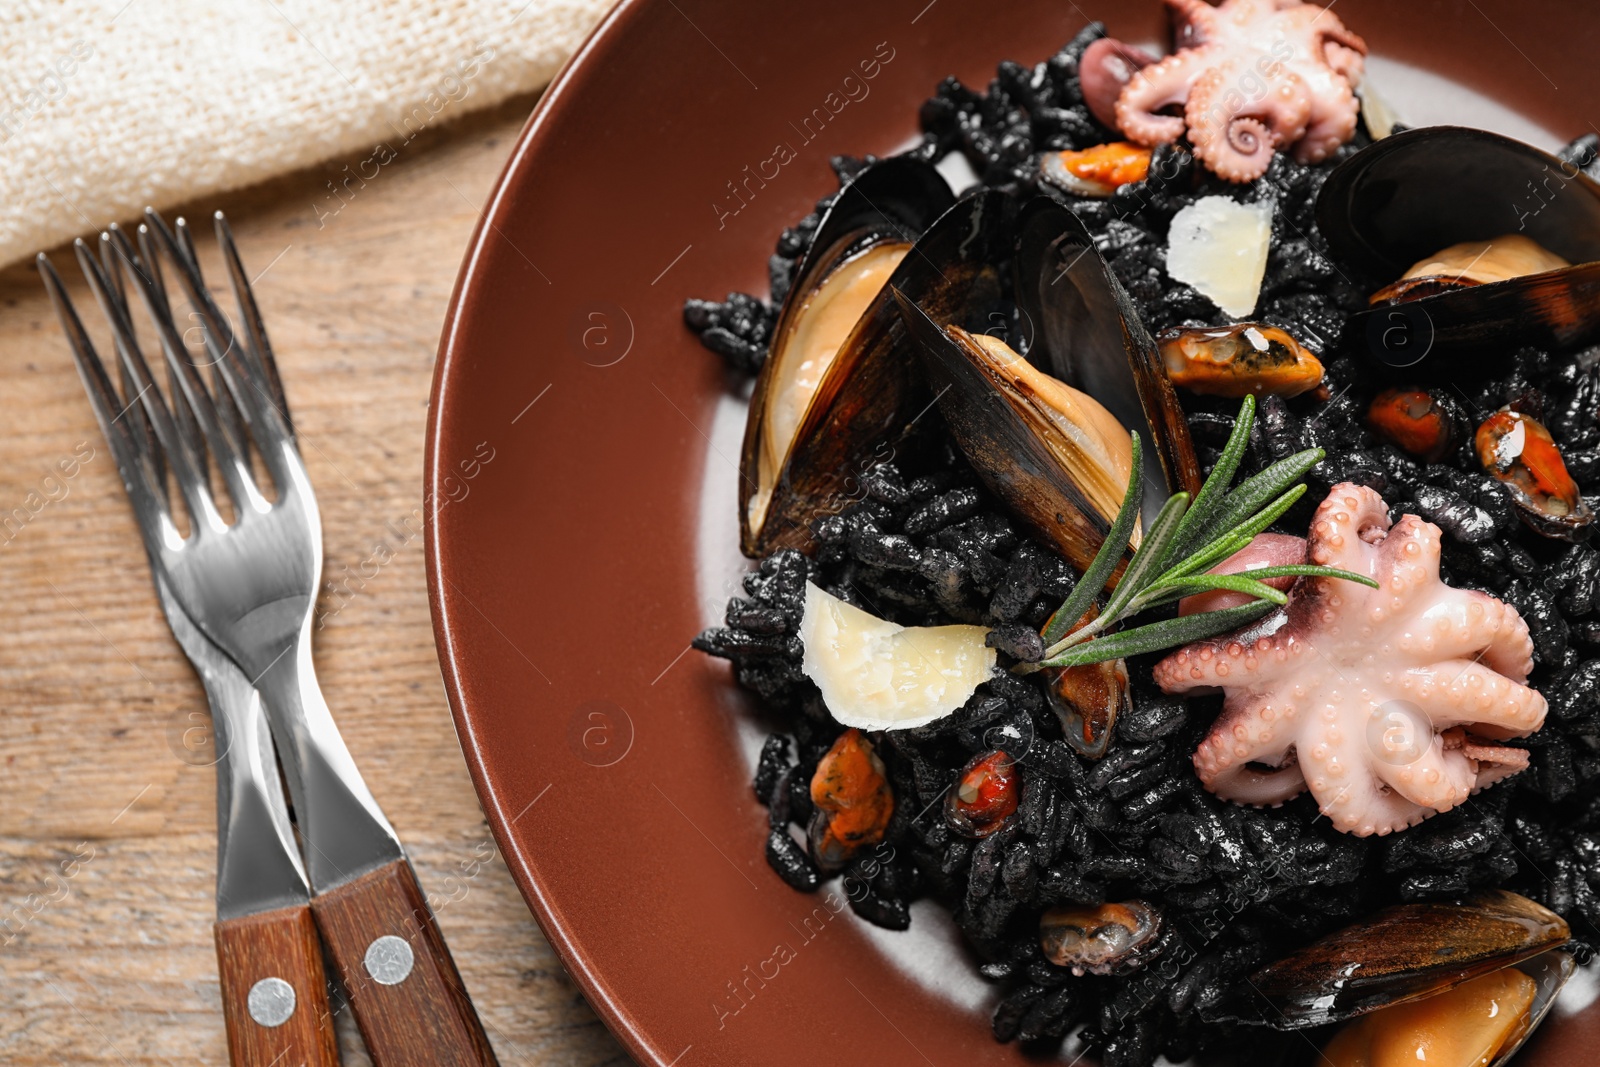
<box><xmin>0</xmin><ymin>98</ymin><xmax>629</xmax><ymax>1067</ymax></box>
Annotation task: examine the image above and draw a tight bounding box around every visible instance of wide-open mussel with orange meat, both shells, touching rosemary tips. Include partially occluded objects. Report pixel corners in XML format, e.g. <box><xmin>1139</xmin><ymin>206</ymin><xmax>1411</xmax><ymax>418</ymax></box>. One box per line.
<box><xmin>899</xmin><ymin>197</ymin><xmax>1200</xmax><ymax>569</ymax></box>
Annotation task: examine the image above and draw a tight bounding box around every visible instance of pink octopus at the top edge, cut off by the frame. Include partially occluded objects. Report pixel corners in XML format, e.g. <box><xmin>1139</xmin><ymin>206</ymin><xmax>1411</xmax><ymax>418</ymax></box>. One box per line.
<box><xmin>1078</xmin><ymin>0</ymin><xmax>1366</xmax><ymax>182</ymax></box>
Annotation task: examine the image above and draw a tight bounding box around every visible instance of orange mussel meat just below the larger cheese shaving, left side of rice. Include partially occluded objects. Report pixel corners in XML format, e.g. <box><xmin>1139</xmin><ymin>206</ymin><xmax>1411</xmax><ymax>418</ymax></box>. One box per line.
<box><xmin>810</xmin><ymin>729</ymin><xmax>894</xmax><ymax>870</ymax></box>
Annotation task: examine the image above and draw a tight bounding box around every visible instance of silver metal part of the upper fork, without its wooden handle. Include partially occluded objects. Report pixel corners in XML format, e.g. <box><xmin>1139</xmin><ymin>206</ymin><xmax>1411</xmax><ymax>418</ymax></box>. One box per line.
<box><xmin>38</xmin><ymin>211</ymin><xmax>405</xmax><ymax>891</ymax></box>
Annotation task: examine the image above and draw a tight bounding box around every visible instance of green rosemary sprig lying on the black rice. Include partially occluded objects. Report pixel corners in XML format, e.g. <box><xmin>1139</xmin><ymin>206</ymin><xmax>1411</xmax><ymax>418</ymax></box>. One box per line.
<box><xmin>1014</xmin><ymin>397</ymin><xmax>1378</xmax><ymax>673</ymax></box>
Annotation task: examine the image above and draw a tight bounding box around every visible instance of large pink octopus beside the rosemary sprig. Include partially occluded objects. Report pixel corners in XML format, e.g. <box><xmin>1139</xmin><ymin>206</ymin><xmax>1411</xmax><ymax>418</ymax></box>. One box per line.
<box><xmin>1155</xmin><ymin>483</ymin><xmax>1546</xmax><ymax>837</ymax></box>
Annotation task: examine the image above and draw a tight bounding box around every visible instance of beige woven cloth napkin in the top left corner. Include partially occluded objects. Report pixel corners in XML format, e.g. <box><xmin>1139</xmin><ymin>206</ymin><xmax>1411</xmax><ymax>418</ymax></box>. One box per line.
<box><xmin>0</xmin><ymin>0</ymin><xmax>610</xmax><ymax>266</ymax></box>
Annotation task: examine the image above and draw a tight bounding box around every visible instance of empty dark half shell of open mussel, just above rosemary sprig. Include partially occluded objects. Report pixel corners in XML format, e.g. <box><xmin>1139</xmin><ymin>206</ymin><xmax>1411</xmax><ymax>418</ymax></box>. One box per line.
<box><xmin>1011</xmin><ymin>197</ymin><xmax>1200</xmax><ymax>524</ymax></box>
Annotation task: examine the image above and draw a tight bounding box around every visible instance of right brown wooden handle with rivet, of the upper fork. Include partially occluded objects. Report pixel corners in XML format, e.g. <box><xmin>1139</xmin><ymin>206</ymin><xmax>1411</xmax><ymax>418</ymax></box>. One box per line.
<box><xmin>310</xmin><ymin>859</ymin><xmax>498</xmax><ymax>1067</ymax></box>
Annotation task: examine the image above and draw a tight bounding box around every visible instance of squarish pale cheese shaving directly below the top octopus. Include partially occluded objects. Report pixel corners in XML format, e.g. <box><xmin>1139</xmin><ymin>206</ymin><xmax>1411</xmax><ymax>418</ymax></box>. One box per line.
<box><xmin>1166</xmin><ymin>197</ymin><xmax>1273</xmax><ymax>315</ymax></box>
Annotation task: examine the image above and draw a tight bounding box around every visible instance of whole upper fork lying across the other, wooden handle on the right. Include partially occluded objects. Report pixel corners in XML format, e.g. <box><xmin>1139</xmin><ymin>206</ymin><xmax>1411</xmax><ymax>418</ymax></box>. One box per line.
<box><xmin>38</xmin><ymin>210</ymin><xmax>496</xmax><ymax>1067</ymax></box>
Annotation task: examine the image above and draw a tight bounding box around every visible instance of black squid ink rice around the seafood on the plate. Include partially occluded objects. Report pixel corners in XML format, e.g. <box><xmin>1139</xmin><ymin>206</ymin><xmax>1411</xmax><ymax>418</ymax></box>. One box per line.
<box><xmin>685</xmin><ymin>24</ymin><xmax>1600</xmax><ymax>1067</ymax></box>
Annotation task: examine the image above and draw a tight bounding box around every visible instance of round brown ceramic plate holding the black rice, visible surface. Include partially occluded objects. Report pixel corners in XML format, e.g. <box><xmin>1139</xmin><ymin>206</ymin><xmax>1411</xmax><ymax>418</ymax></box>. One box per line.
<box><xmin>426</xmin><ymin>0</ymin><xmax>1600</xmax><ymax>1067</ymax></box>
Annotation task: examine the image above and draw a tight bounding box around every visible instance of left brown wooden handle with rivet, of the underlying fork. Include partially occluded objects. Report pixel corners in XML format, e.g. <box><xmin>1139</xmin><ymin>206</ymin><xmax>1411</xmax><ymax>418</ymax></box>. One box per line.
<box><xmin>214</xmin><ymin>904</ymin><xmax>339</xmax><ymax>1067</ymax></box>
